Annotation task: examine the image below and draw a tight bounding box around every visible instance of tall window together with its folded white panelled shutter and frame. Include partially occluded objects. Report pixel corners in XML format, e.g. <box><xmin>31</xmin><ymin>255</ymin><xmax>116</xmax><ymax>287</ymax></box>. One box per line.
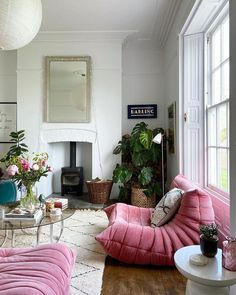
<box><xmin>181</xmin><ymin>1</ymin><xmax>229</xmax><ymax>197</ymax></box>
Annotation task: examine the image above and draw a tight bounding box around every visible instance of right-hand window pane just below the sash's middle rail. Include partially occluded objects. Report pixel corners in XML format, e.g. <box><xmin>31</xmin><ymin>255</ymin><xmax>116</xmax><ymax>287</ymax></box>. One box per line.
<box><xmin>215</xmin><ymin>104</ymin><xmax>228</xmax><ymax>147</ymax></box>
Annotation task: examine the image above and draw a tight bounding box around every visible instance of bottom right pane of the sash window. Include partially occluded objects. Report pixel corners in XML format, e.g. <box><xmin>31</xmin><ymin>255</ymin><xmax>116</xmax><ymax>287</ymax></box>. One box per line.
<box><xmin>217</xmin><ymin>149</ymin><xmax>229</xmax><ymax>192</ymax></box>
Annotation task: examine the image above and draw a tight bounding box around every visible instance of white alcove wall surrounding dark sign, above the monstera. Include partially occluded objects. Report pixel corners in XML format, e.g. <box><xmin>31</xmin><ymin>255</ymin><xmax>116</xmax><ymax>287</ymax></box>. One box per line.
<box><xmin>122</xmin><ymin>40</ymin><xmax>165</xmax><ymax>134</ymax></box>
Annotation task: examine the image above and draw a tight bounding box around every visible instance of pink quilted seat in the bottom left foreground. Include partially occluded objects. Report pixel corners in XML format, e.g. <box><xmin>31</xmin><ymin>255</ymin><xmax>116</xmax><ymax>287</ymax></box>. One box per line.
<box><xmin>0</xmin><ymin>244</ymin><xmax>75</xmax><ymax>295</ymax></box>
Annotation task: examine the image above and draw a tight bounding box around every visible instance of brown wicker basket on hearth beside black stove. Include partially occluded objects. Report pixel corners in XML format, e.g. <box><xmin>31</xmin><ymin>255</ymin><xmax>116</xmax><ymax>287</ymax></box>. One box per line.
<box><xmin>86</xmin><ymin>180</ymin><xmax>113</xmax><ymax>204</ymax></box>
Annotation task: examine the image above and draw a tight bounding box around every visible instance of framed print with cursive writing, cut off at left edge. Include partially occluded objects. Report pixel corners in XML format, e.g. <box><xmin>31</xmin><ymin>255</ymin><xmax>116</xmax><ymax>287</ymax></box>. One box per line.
<box><xmin>0</xmin><ymin>102</ymin><xmax>16</xmax><ymax>143</ymax></box>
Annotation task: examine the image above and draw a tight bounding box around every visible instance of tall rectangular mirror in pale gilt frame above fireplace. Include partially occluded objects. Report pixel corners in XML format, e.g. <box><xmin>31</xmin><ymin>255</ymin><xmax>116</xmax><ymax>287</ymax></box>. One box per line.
<box><xmin>45</xmin><ymin>56</ymin><xmax>91</xmax><ymax>123</ymax></box>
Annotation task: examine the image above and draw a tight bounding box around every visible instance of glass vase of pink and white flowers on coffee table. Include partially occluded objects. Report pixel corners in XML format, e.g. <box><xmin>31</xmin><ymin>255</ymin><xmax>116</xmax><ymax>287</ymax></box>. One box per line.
<box><xmin>6</xmin><ymin>152</ymin><xmax>52</xmax><ymax>209</ymax></box>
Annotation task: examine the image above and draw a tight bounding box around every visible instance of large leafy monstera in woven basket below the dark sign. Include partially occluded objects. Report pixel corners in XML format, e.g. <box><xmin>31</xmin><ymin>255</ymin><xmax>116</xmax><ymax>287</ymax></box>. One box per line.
<box><xmin>112</xmin><ymin>122</ymin><xmax>164</xmax><ymax>207</ymax></box>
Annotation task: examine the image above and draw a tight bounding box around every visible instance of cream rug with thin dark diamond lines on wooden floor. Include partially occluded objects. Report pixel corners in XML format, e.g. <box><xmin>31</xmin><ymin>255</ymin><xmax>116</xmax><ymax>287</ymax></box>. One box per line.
<box><xmin>1</xmin><ymin>210</ymin><xmax>108</xmax><ymax>295</ymax></box>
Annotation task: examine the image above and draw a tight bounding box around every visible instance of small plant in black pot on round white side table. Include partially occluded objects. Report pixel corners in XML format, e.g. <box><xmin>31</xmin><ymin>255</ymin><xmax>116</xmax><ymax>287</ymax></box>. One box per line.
<box><xmin>200</xmin><ymin>223</ymin><xmax>219</xmax><ymax>257</ymax></box>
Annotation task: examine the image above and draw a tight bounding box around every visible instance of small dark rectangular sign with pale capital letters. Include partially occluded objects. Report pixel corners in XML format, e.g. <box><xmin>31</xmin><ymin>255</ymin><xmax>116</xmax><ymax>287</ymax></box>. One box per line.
<box><xmin>128</xmin><ymin>104</ymin><xmax>157</xmax><ymax>119</ymax></box>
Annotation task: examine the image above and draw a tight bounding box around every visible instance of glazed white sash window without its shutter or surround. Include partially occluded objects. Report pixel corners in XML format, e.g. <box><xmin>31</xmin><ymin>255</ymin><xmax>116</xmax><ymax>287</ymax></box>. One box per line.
<box><xmin>206</xmin><ymin>15</ymin><xmax>229</xmax><ymax>194</ymax></box>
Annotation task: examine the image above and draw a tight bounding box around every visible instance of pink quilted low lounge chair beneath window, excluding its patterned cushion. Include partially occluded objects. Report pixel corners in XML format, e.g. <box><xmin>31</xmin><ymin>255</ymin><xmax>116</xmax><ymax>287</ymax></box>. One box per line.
<box><xmin>96</xmin><ymin>175</ymin><xmax>214</xmax><ymax>265</ymax></box>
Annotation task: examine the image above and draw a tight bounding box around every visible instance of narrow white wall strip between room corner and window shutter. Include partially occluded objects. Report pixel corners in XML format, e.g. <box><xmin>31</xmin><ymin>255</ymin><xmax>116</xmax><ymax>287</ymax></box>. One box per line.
<box><xmin>163</xmin><ymin>0</ymin><xmax>195</xmax><ymax>182</ymax></box>
